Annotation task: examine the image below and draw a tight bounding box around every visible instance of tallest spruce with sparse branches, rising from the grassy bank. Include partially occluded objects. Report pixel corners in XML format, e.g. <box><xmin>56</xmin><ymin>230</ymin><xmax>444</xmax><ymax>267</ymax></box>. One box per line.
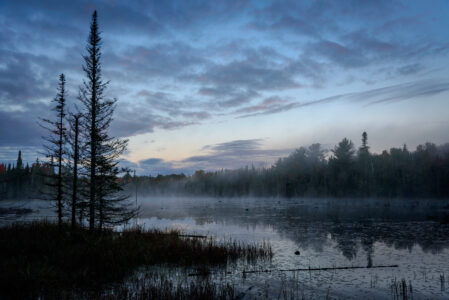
<box><xmin>79</xmin><ymin>11</ymin><xmax>133</xmax><ymax>230</ymax></box>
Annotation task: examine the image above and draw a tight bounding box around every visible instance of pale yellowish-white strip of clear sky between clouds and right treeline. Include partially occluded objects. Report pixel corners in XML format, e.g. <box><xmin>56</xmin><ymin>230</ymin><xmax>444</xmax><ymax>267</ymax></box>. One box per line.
<box><xmin>122</xmin><ymin>96</ymin><xmax>449</xmax><ymax>167</ymax></box>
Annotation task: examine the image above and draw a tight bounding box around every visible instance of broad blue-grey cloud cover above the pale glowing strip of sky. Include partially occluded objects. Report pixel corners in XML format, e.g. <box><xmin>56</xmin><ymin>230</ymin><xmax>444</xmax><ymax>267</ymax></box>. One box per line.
<box><xmin>0</xmin><ymin>0</ymin><xmax>449</xmax><ymax>159</ymax></box>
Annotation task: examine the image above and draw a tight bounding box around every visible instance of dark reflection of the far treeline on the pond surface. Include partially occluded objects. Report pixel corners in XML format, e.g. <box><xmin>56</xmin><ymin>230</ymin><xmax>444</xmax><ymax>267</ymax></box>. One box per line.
<box><xmin>136</xmin><ymin>198</ymin><xmax>449</xmax><ymax>258</ymax></box>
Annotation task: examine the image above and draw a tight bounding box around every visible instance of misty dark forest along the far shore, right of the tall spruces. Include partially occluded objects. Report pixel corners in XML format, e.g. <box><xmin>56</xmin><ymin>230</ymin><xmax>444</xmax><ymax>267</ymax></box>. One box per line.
<box><xmin>125</xmin><ymin>133</ymin><xmax>449</xmax><ymax>198</ymax></box>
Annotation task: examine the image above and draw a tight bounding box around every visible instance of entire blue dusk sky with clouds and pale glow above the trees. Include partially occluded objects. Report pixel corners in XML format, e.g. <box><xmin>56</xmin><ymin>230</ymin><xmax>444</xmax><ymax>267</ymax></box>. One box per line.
<box><xmin>0</xmin><ymin>0</ymin><xmax>449</xmax><ymax>175</ymax></box>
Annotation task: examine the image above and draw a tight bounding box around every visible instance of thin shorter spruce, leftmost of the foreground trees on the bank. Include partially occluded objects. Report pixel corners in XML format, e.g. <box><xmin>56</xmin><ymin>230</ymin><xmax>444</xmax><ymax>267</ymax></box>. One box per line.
<box><xmin>42</xmin><ymin>74</ymin><xmax>67</xmax><ymax>226</ymax></box>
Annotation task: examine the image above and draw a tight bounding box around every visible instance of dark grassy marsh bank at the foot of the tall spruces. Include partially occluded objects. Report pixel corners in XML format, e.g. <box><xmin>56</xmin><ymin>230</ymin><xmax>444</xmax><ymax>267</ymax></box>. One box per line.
<box><xmin>0</xmin><ymin>222</ymin><xmax>272</xmax><ymax>299</ymax></box>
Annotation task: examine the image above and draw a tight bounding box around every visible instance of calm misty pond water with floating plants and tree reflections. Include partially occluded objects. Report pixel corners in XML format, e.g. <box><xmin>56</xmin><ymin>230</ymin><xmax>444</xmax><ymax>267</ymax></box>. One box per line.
<box><xmin>2</xmin><ymin>197</ymin><xmax>449</xmax><ymax>299</ymax></box>
